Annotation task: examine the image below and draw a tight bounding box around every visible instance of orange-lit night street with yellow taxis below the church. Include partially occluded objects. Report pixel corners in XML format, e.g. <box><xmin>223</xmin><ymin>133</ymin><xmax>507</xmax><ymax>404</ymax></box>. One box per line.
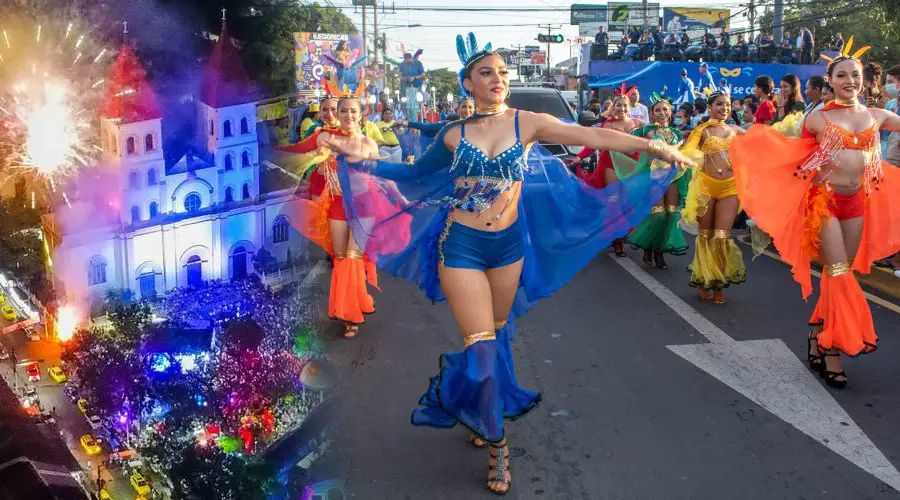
<box><xmin>0</xmin><ymin>325</ymin><xmax>136</xmax><ymax>498</ymax></box>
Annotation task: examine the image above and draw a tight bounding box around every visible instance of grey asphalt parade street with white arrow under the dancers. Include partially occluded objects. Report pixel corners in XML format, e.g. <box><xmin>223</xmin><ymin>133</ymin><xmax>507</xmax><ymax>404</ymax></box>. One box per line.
<box><xmin>318</xmin><ymin>235</ymin><xmax>900</xmax><ymax>500</ymax></box>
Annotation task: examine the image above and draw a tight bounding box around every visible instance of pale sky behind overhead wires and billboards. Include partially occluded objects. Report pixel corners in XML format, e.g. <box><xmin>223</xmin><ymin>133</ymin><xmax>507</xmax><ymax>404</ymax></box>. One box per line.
<box><xmin>334</xmin><ymin>0</ymin><xmax>761</xmax><ymax>70</ymax></box>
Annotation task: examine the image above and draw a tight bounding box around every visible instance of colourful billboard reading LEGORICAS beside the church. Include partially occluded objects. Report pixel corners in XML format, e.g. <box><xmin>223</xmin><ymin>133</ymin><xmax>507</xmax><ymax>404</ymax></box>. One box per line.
<box><xmin>294</xmin><ymin>32</ymin><xmax>365</xmax><ymax>99</ymax></box>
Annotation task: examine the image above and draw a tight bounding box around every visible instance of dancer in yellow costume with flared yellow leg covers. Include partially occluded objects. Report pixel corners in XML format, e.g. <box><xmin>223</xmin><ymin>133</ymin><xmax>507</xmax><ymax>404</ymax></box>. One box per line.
<box><xmin>682</xmin><ymin>91</ymin><xmax>744</xmax><ymax>304</ymax></box>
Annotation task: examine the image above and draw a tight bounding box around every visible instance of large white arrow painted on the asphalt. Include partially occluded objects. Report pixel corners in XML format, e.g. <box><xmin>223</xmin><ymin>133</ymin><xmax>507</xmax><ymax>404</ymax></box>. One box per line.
<box><xmin>613</xmin><ymin>258</ymin><xmax>900</xmax><ymax>491</ymax></box>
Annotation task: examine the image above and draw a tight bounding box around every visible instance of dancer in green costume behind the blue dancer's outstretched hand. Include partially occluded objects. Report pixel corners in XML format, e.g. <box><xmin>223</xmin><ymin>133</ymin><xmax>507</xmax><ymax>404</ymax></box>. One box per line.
<box><xmin>627</xmin><ymin>93</ymin><xmax>691</xmax><ymax>269</ymax></box>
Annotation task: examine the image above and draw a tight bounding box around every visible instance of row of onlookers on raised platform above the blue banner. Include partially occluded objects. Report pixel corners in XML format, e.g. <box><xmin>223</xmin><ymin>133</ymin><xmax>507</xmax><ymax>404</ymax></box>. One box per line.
<box><xmin>594</xmin><ymin>25</ymin><xmax>844</xmax><ymax>64</ymax></box>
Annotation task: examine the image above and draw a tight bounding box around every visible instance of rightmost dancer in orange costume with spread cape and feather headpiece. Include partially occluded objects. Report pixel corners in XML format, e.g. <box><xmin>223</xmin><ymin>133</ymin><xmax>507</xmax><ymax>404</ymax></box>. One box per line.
<box><xmin>731</xmin><ymin>43</ymin><xmax>900</xmax><ymax>389</ymax></box>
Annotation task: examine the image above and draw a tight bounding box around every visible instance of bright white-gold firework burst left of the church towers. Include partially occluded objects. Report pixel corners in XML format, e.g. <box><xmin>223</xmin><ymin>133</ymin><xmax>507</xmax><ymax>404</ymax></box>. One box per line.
<box><xmin>0</xmin><ymin>9</ymin><xmax>110</xmax><ymax>204</ymax></box>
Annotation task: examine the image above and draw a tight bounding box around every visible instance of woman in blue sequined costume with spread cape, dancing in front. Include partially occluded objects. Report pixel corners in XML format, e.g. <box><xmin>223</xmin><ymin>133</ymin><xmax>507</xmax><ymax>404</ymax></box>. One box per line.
<box><xmin>328</xmin><ymin>34</ymin><xmax>691</xmax><ymax>494</ymax></box>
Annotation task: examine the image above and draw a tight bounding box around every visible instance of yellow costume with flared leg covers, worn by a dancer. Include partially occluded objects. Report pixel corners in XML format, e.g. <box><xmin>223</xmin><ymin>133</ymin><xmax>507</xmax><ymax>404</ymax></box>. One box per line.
<box><xmin>682</xmin><ymin>121</ymin><xmax>747</xmax><ymax>290</ymax></box>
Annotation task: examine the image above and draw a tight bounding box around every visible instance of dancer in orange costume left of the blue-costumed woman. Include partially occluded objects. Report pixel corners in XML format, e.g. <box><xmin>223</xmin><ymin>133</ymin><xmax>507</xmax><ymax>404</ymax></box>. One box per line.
<box><xmin>283</xmin><ymin>82</ymin><xmax>402</xmax><ymax>338</ymax></box>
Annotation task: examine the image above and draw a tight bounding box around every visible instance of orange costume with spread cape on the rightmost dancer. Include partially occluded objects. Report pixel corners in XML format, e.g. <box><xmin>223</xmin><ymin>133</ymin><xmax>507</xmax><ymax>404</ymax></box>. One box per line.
<box><xmin>730</xmin><ymin>109</ymin><xmax>900</xmax><ymax>356</ymax></box>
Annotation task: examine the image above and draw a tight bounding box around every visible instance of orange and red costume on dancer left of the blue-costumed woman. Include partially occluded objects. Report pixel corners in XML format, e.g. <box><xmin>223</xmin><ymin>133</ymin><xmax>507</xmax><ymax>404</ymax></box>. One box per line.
<box><xmin>280</xmin><ymin>126</ymin><xmax>409</xmax><ymax>324</ymax></box>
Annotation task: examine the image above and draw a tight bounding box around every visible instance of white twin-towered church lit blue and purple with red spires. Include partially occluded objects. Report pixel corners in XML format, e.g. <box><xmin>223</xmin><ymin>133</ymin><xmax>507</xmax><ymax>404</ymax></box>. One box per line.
<box><xmin>49</xmin><ymin>32</ymin><xmax>306</xmax><ymax>308</ymax></box>
